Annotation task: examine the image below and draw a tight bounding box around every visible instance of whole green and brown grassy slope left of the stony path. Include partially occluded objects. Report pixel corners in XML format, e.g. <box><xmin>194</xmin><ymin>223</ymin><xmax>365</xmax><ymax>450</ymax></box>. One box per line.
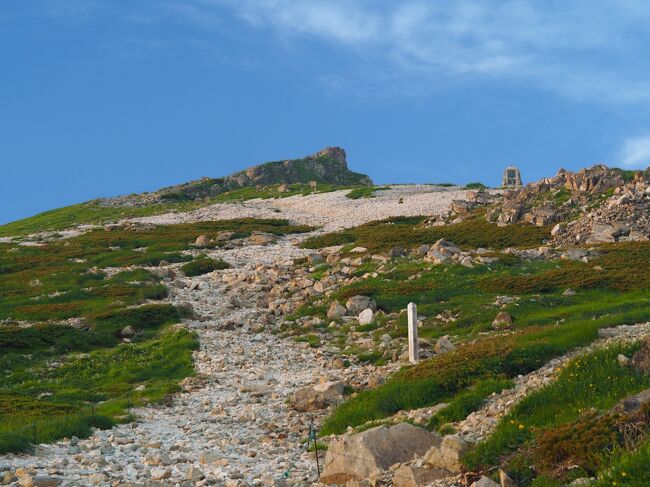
<box><xmin>0</xmin><ymin>219</ymin><xmax>307</xmax><ymax>452</ymax></box>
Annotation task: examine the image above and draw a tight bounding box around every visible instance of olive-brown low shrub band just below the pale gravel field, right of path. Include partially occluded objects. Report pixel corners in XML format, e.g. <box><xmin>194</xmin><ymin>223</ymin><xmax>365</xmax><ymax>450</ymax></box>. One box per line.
<box><xmin>303</xmin><ymin>217</ymin><xmax>550</xmax><ymax>252</ymax></box>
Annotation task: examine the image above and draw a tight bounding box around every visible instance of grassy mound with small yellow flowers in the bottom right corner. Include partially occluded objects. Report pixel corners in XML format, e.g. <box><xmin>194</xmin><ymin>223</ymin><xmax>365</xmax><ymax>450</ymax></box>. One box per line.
<box><xmin>465</xmin><ymin>346</ymin><xmax>650</xmax><ymax>483</ymax></box>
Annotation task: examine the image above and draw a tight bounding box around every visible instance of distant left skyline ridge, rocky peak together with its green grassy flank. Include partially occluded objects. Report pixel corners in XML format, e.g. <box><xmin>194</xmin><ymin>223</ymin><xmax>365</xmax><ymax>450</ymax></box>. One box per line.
<box><xmin>0</xmin><ymin>147</ymin><xmax>372</xmax><ymax>237</ymax></box>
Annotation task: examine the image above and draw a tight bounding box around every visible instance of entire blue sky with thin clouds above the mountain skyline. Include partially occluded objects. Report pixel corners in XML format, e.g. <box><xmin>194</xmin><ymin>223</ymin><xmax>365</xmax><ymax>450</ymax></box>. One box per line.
<box><xmin>0</xmin><ymin>0</ymin><xmax>650</xmax><ymax>223</ymax></box>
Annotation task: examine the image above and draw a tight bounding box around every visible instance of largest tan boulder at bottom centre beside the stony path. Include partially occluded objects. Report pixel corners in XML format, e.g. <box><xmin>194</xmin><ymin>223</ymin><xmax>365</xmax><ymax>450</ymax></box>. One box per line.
<box><xmin>320</xmin><ymin>423</ymin><xmax>441</xmax><ymax>484</ymax></box>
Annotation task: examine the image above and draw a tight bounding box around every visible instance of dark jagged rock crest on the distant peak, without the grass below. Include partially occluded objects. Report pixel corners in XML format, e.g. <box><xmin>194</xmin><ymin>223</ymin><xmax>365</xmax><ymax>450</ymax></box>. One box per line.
<box><xmin>99</xmin><ymin>147</ymin><xmax>372</xmax><ymax>206</ymax></box>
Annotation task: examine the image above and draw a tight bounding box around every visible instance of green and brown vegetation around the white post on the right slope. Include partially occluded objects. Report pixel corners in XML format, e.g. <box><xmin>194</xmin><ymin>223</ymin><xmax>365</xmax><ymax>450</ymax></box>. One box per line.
<box><xmin>316</xmin><ymin>242</ymin><xmax>650</xmax><ymax>434</ymax></box>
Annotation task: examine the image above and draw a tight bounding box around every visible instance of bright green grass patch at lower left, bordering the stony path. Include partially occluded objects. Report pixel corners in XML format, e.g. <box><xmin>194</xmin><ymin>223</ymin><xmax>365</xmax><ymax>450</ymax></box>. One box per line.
<box><xmin>0</xmin><ymin>330</ymin><xmax>198</xmax><ymax>453</ymax></box>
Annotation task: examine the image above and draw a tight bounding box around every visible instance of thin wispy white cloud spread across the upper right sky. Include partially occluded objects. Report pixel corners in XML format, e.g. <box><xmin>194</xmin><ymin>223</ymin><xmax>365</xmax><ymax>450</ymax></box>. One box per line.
<box><xmin>194</xmin><ymin>0</ymin><xmax>650</xmax><ymax>103</ymax></box>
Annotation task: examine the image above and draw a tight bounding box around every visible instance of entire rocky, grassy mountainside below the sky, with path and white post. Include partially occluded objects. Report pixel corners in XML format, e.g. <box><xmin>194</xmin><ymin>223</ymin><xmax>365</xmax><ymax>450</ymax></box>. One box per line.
<box><xmin>0</xmin><ymin>160</ymin><xmax>650</xmax><ymax>487</ymax></box>
